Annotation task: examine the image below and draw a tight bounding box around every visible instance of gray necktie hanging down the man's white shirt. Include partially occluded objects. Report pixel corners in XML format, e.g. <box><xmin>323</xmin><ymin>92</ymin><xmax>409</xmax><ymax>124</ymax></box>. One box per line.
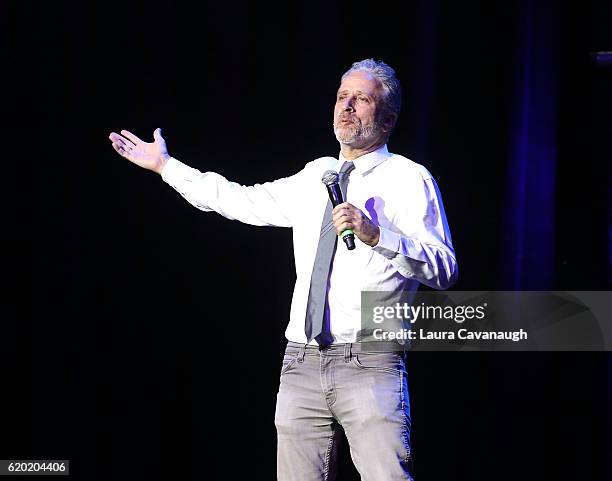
<box><xmin>304</xmin><ymin>161</ymin><xmax>355</xmax><ymax>346</ymax></box>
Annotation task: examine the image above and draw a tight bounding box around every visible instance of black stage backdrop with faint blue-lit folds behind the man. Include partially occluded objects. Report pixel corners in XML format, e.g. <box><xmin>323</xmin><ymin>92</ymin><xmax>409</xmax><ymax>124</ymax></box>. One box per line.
<box><xmin>5</xmin><ymin>0</ymin><xmax>612</xmax><ymax>481</ymax></box>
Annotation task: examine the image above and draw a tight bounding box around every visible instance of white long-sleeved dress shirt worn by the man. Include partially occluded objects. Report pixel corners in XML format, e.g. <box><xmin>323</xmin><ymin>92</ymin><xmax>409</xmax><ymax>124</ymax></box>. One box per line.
<box><xmin>161</xmin><ymin>145</ymin><xmax>457</xmax><ymax>344</ymax></box>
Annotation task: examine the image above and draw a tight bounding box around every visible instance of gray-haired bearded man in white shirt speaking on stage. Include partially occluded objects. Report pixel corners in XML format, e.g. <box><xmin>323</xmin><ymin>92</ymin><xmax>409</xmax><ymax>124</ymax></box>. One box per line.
<box><xmin>110</xmin><ymin>59</ymin><xmax>457</xmax><ymax>481</ymax></box>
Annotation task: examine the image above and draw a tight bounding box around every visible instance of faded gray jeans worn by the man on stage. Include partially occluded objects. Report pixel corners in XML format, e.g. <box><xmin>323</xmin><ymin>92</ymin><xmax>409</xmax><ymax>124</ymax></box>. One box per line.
<box><xmin>275</xmin><ymin>342</ymin><xmax>412</xmax><ymax>481</ymax></box>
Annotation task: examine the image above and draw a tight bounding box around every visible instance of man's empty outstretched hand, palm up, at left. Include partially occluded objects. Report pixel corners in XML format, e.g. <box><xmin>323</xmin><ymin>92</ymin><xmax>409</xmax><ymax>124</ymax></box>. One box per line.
<box><xmin>108</xmin><ymin>129</ymin><xmax>170</xmax><ymax>174</ymax></box>
